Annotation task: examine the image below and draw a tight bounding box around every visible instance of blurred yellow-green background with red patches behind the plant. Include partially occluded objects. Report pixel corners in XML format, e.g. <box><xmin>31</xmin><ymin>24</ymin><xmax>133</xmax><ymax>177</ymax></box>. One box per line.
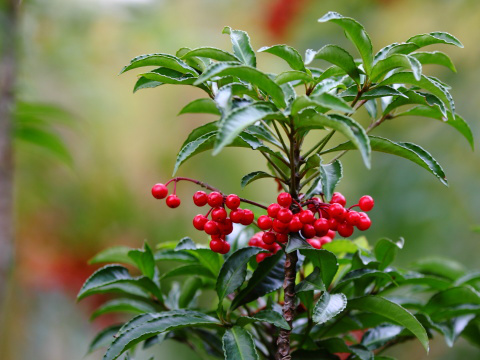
<box><xmin>0</xmin><ymin>0</ymin><xmax>480</xmax><ymax>360</ymax></box>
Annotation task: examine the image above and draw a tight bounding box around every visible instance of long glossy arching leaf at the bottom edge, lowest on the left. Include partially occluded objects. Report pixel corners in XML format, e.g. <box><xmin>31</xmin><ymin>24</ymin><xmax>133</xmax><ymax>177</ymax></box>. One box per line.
<box><xmin>103</xmin><ymin>310</ymin><xmax>220</xmax><ymax>360</ymax></box>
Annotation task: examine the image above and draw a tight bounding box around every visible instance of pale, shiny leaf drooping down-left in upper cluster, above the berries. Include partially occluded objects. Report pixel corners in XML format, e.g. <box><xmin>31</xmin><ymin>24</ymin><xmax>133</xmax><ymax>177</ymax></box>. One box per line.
<box><xmin>213</xmin><ymin>104</ymin><xmax>274</xmax><ymax>155</ymax></box>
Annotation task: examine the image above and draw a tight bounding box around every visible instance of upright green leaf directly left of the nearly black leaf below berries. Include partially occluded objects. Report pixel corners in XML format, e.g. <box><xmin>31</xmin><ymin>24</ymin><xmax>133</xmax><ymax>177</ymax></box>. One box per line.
<box><xmin>216</xmin><ymin>247</ymin><xmax>264</xmax><ymax>303</ymax></box>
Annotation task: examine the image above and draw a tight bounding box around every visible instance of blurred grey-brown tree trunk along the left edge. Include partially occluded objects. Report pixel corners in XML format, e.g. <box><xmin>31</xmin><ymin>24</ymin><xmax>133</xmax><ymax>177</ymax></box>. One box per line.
<box><xmin>0</xmin><ymin>0</ymin><xmax>20</xmax><ymax>320</ymax></box>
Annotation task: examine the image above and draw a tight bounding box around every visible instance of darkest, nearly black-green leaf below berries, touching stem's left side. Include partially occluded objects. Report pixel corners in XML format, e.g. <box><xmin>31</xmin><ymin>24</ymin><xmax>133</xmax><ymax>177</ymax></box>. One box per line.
<box><xmin>230</xmin><ymin>251</ymin><xmax>285</xmax><ymax>310</ymax></box>
